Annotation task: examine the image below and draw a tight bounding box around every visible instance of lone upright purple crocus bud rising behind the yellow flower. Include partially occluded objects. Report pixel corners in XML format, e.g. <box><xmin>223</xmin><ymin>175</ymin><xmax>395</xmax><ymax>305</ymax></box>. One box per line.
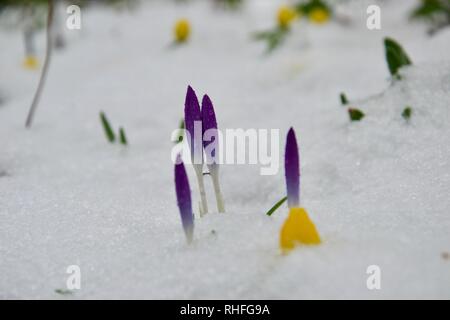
<box><xmin>284</xmin><ymin>128</ymin><xmax>300</xmax><ymax>208</ymax></box>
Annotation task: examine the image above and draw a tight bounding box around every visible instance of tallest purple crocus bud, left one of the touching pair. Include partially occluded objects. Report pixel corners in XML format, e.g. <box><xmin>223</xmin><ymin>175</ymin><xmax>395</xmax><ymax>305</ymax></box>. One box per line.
<box><xmin>184</xmin><ymin>86</ymin><xmax>203</xmax><ymax>164</ymax></box>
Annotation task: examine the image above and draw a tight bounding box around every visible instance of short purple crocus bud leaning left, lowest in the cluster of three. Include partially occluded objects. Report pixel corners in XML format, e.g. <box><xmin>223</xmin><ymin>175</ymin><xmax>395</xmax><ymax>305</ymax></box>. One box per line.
<box><xmin>175</xmin><ymin>155</ymin><xmax>194</xmax><ymax>243</ymax></box>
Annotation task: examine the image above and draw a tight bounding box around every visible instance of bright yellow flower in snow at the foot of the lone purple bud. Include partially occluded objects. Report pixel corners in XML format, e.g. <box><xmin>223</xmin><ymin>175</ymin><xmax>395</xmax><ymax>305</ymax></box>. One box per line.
<box><xmin>280</xmin><ymin>208</ymin><xmax>321</xmax><ymax>252</ymax></box>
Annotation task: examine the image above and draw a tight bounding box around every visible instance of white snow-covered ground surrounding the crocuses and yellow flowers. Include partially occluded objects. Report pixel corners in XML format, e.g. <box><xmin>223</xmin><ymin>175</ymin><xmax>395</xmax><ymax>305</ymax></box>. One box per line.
<box><xmin>0</xmin><ymin>0</ymin><xmax>450</xmax><ymax>299</ymax></box>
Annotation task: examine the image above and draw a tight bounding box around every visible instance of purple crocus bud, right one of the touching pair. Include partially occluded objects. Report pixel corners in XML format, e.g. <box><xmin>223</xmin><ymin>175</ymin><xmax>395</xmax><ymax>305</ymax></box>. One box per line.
<box><xmin>202</xmin><ymin>94</ymin><xmax>219</xmax><ymax>164</ymax></box>
